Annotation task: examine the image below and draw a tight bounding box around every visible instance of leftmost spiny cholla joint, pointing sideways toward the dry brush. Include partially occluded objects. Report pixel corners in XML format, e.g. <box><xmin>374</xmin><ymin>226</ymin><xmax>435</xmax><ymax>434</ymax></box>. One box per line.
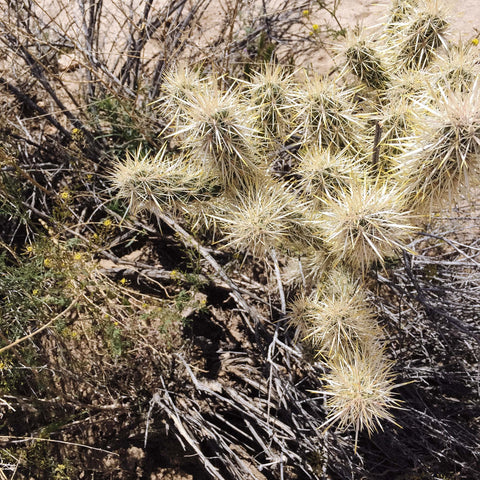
<box><xmin>110</xmin><ymin>146</ymin><xmax>206</xmax><ymax>212</ymax></box>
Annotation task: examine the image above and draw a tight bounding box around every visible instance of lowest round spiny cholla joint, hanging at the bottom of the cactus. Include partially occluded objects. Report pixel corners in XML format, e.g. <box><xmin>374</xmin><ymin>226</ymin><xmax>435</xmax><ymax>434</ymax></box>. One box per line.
<box><xmin>315</xmin><ymin>344</ymin><xmax>400</xmax><ymax>448</ymax></box>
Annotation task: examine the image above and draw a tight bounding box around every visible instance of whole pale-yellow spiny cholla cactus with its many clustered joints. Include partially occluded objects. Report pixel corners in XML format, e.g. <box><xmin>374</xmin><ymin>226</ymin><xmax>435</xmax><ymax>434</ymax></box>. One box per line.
<box><xmin>112</xmin><ymin>0</ymin><xmax>480</xmax><ymax>450</ymax></box>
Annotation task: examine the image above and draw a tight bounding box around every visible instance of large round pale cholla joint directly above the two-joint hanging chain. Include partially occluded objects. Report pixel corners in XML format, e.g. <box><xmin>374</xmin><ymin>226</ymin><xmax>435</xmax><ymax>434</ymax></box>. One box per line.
<box><xmin>320</xmin><ymin>180</ymin><xmax>414</xmax><ymax>272</ymax></box>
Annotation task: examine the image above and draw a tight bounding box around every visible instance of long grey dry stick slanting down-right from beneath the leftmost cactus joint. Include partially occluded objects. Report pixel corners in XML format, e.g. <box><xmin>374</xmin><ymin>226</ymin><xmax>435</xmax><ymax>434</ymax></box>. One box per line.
<box><xmin>156</xmin><ymin>211</ymin><xmax>261</xmax><ymax>332</ymax></box>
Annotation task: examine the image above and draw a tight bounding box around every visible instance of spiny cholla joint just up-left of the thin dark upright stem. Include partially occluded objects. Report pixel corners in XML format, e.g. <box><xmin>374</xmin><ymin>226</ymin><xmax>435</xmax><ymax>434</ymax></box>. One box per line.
<box><xmin>292</xmin><ymin>77</ymin><xmax>363</xmax><ymax>150</ymax></box>
